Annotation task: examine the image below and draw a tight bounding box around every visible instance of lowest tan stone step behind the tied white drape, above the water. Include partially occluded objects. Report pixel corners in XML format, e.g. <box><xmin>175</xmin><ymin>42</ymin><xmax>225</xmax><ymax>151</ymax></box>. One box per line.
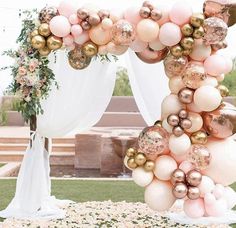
<box><xmin>0</xmin><ymin>151</ymin><xmax>75</xmax><ymax>165</ymax></box>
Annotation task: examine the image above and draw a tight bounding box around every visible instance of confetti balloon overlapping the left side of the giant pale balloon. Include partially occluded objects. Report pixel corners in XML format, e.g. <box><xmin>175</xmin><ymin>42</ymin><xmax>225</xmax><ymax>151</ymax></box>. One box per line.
<box><xmin>188</xmin><ymin>144</ymin><xmax>211</xmax><ymax>170</ymax></box>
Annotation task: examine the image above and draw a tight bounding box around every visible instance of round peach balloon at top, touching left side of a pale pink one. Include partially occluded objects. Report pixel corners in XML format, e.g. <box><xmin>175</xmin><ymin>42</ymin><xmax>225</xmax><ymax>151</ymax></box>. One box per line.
<box><xmin>136</xmin><ymin>19</ymin><xmax>159</xmax><ymax>42</ymax></box>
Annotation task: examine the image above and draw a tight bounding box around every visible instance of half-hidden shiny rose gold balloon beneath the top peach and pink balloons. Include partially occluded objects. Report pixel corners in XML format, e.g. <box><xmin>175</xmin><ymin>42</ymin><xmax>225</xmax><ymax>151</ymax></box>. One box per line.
<box><xmin>135</xmin><ymin>48</ymin><xmax>169</xmax><ymax>64</ymax></box>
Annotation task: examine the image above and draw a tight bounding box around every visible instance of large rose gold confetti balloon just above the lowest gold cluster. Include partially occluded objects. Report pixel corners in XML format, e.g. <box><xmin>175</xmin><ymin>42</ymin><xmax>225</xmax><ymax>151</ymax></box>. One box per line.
<box><xmin>138</xmin><ymin>126</ymin><xmax>169</xmax><ymax>159</ymax></box>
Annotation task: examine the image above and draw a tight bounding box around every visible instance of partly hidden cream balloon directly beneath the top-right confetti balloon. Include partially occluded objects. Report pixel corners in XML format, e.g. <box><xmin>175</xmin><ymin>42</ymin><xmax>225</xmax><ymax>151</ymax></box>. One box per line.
<box><xmin>190</xmin><ymin>40</ymin><xmax>211</xmax><ymax>62</ymax></box>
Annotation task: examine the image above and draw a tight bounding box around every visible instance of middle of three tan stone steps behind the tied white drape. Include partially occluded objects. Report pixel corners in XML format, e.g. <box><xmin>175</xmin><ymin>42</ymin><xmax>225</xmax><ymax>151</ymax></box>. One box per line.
<box><xmin>0</xmin><ymin>143</ymin><xmax>75</xmax><ymax>152</ymax></box>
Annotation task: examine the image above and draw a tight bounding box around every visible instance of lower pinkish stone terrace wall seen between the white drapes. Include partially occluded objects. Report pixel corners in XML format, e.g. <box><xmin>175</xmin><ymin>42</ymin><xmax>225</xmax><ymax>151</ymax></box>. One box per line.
<box><xmin>95</xmin><ymin>112</ymin><xmax>147</xmax><ymax>127</ymax></box>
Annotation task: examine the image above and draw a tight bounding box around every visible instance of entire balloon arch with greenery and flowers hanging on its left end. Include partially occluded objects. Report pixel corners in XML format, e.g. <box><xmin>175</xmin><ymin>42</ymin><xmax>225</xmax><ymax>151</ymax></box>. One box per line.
<box><xmin>3</xmin><ymin>1</ymin><xmax>236</xmax><ymax>221</ymax></box>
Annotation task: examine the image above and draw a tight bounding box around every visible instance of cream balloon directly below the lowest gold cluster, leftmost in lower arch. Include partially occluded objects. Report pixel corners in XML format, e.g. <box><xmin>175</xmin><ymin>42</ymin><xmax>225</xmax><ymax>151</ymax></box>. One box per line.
<box><xmin>132</xmin><ymin>167</ymin><xmax>154</xmax><ymax>187</ymax></box>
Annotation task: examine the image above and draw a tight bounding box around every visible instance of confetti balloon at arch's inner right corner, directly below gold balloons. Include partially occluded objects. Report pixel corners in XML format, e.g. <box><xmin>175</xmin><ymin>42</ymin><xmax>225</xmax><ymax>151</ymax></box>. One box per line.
<box><xmin>164</xmin><ymin>55</ymin><xmax>188</xmax><ymax>77</ymax></box>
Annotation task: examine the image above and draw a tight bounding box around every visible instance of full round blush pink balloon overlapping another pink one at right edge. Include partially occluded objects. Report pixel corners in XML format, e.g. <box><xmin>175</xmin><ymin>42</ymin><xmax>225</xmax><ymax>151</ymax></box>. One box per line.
<box><xmin>204</xmin><ymin>55</ymin><xmax>226</xmax><ymax>76</ymax></box>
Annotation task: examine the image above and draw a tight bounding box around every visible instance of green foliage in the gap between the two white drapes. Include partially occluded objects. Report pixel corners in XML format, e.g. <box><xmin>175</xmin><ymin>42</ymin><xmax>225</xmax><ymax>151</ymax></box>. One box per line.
<box><xmin>113</xmin><ymin>68</ymin><xmax>133</xmax><ymax>96</ymax></box>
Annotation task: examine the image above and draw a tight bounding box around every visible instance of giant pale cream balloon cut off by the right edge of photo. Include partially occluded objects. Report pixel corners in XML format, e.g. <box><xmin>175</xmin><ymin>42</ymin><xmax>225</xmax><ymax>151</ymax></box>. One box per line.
<box><xmin>203</xmin><ymin>136</ymin><xmax>236</xmax><ymax>186</ymax></box>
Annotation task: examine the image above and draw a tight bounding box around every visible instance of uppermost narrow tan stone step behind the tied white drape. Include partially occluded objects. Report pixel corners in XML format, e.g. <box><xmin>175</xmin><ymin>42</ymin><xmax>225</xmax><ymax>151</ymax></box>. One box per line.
<box><xmin>0</xmin><ymin>137</ymin><xmax>75</xmax><ymax>144</ymax></box>
